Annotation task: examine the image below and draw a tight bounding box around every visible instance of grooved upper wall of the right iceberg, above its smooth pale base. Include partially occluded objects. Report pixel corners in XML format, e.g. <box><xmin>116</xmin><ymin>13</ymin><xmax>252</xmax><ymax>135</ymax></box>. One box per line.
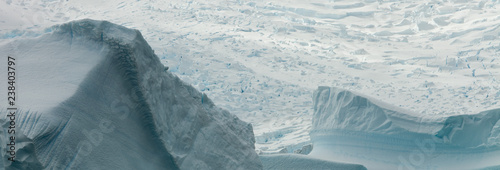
<box><xmin>311</xmin><ymin>86</ymin><xmax>500</xmax><ymax>148</ymax></box>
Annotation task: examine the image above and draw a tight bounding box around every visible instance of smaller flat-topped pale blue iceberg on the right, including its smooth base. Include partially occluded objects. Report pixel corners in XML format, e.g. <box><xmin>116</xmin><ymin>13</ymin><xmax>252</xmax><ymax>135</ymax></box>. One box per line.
<box><xmin>310</xmin><ymin>87</ymin><xmax>500</xmax><ymax>169</ymax></box>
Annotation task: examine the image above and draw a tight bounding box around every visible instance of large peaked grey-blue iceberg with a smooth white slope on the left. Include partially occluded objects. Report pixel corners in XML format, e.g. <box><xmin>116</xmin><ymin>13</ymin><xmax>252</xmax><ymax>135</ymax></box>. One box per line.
<box><xmin>0</xmin><ymin>20</ymin><xmax>262</xmax><ymax>169</ymax></box>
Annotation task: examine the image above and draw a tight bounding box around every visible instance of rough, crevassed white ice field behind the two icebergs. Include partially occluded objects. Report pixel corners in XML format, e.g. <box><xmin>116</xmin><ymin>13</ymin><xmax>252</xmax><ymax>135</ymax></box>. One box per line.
<box><xmin>0</xmin><ymin>0</ymin><xmax>500</xmax><ymax>153</ymax></box>
